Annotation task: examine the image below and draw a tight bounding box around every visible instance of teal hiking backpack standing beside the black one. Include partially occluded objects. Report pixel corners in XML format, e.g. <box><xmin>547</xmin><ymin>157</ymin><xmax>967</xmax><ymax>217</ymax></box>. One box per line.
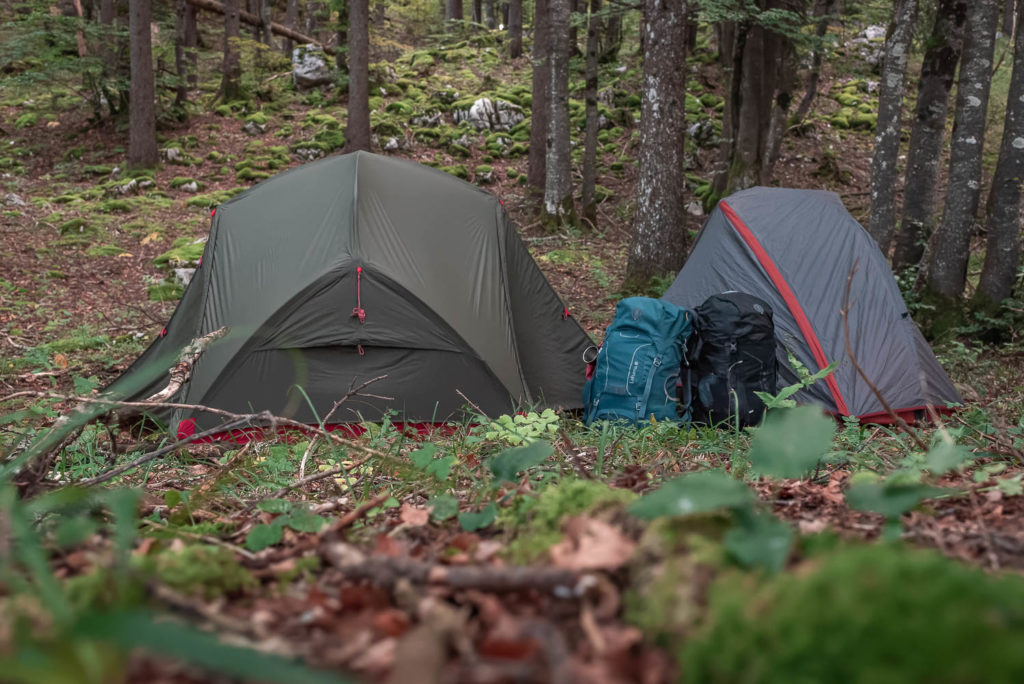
<box><xmin>583</xmin><ymin>297</ymin><xmax>693</xmax><ymax>425</ymax></box>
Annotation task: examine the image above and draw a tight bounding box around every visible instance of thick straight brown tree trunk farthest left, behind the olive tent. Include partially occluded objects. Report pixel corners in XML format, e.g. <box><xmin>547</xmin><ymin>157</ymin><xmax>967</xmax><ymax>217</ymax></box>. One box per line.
<box><xmin>128</xmin><ymin>0</ymin><xmax>160</xmax><ymax>169</ymax></box>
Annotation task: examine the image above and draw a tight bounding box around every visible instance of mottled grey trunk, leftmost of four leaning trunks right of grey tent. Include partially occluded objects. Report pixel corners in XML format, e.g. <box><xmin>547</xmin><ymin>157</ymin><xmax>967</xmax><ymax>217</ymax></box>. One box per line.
<box><xmin>867</xmin><ymin>0</ymin><xmax>918</xmax><ymax>256</ymax></box>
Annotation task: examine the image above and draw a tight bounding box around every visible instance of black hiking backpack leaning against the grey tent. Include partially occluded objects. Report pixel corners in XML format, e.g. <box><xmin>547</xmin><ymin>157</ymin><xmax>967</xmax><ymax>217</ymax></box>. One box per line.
<box><xmin>680</xmin><ymin>292</ymin><xmax>778</xmax><ymax>426</ymax></box>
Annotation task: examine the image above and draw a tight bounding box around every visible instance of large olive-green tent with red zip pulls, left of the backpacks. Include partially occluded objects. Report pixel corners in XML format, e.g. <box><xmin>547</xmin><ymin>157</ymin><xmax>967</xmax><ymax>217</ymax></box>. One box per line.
<box><xmin>109</xmin><ymin>153</ymin><xmax>590</xmax><ymax>431</ymax></box>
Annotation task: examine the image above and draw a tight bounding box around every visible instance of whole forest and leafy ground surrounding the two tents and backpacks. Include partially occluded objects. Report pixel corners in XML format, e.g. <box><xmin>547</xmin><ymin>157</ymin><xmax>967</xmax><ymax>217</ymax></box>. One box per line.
<box><xmin>0</xmin><ymin>0</ymin><xmax>1024</xmax><ymax>682</ymax></box>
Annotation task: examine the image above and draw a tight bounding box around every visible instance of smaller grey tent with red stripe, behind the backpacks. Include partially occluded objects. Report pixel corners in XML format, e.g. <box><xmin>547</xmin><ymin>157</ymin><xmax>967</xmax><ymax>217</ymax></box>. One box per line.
<box><xmin>664</xmin><ymin>187</ymin><xmax>961</xmax><ymax>422</ymax></box>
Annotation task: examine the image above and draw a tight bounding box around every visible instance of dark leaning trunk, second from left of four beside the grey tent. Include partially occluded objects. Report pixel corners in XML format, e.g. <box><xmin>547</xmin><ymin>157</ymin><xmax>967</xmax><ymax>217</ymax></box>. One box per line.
<box><xmin>893</xmin><ymin>0</ymin><xmax>968</xmax><ymax>271</ymax></box>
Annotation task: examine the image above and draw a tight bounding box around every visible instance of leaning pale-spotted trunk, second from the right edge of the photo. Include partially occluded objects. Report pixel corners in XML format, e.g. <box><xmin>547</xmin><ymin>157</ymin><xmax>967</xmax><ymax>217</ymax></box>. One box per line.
<box><xmin>927</xmin><ymin>0</ymin><xmax>999</xmax><ymax>300</ymax></box>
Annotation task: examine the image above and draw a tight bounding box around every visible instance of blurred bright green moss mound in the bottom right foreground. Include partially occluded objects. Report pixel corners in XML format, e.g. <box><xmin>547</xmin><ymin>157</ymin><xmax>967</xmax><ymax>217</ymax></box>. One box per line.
<box><xmin>675</xmin><ymin>546</ymin><xmax>1024</xmax><ymax>683</ymax></box>
